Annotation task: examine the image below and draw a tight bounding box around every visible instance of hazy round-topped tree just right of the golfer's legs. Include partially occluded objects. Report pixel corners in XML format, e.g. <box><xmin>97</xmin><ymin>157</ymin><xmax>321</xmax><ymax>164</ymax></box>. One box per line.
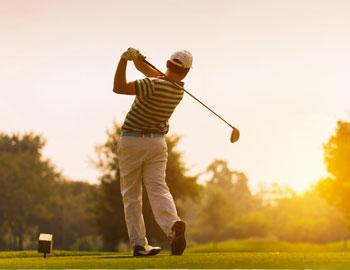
<box><xmin>193</xmin><ymin>160</ymin><xmax>258</xmax><ymax>242</ymax></box>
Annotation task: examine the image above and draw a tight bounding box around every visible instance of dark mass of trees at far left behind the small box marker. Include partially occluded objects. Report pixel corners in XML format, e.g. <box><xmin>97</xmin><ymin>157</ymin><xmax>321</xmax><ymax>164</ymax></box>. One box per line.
<box><xmin>0</xmin><ymin>133</ymin><xmax>99</xmax><ymax>250</ymax></box>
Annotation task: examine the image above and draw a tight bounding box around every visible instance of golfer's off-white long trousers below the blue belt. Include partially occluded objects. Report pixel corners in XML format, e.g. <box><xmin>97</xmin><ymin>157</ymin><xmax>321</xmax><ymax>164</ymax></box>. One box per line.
<box><xmin>117</xmin><ymin>136</ymin><xmax>180</xmax><ymax>247</ymax></box>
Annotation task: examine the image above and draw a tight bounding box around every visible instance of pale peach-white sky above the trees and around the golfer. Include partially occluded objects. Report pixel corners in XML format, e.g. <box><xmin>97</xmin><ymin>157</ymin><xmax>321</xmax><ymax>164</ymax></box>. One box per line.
<box><xmin>0</xmin><ymin>0</ymin><xmax>350</xmax><ymax>191</ymax></box>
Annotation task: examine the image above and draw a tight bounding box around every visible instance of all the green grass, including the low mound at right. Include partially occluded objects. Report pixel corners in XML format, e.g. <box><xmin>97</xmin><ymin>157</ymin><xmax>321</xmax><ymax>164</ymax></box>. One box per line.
<box><xmin>0</xmin><ymin>239</ymin><xmax>350</xmax><ymax>269</ymax></box>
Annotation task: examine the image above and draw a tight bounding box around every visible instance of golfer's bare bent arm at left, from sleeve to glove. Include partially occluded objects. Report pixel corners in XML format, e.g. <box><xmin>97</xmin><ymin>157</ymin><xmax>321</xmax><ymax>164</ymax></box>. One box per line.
<box><xmin>113</xmin><ymin>54</ymin><xmax>136</xmax><ymax>95</ymax></box>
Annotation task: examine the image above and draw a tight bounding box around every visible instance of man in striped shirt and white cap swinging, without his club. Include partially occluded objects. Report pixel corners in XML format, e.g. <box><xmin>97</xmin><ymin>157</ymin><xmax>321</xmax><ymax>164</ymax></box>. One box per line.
<box><xmin>113</xmin><ymin>48</ymin><xmax>192</xmax><ymax>256</ymax></box>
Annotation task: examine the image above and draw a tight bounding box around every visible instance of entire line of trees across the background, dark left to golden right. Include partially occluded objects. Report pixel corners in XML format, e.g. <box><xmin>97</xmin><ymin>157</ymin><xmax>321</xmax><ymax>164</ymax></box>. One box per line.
<box><xmin>0</xmin><ymin>121</ymin><xmax>350</xmax><ymax>251</ymax></box>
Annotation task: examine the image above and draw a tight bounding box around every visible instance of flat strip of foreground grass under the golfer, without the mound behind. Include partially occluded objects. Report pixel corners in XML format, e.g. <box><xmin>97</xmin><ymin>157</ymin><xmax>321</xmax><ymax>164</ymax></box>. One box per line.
<box><xmin>0</xmin><ymin>251</ymin><xmax>350</xmax><ymax>269</ymax></box>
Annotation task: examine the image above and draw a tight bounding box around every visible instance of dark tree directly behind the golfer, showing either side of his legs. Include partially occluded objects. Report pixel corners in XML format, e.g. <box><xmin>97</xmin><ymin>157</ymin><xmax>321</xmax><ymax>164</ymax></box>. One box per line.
<box><xmin>96</xmin><ymin>123</ymin><xmax>200</xmax><ymax>250</ymax></box>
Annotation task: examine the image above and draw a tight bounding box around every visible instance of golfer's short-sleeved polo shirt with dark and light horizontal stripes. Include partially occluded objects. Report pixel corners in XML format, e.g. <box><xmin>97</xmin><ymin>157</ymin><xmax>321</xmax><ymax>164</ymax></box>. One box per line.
<box><xmin>122</xmin><ymin>77</ymin><xmax>184</xmax><ymax>134</ymax></box>
